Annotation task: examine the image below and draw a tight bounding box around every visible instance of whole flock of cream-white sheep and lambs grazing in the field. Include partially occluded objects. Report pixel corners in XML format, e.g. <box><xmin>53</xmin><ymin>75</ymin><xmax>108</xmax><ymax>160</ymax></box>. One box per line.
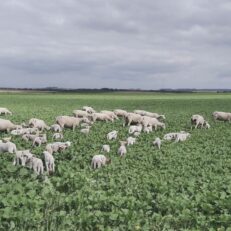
<box><xmin>0</xmin><ymin>106</ymin><xmax>231</xmax><ymax>174</ymax></box>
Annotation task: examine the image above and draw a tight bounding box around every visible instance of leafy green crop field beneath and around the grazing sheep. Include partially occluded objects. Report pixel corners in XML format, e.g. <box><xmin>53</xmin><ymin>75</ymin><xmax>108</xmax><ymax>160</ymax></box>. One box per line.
<box><xmin>0</xmin><ymin>93</ymin><xmax>231</xmax><ymax>231</ymax></box>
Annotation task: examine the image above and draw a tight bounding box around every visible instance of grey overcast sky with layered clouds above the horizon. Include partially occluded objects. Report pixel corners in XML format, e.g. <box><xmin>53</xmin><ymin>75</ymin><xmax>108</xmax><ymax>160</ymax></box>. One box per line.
<box><xmin>0</xmin><ymin>0</ymin><xmax>231</xmax><ymax>89</ymax></box>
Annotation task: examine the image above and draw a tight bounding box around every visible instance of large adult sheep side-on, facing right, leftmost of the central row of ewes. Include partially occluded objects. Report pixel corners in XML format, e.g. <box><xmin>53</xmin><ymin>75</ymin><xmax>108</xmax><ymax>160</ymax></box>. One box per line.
<box><xmin>56</xmin><ymin>116</ymin><xmax>90</xmax><ymax>131</ymax></box>
